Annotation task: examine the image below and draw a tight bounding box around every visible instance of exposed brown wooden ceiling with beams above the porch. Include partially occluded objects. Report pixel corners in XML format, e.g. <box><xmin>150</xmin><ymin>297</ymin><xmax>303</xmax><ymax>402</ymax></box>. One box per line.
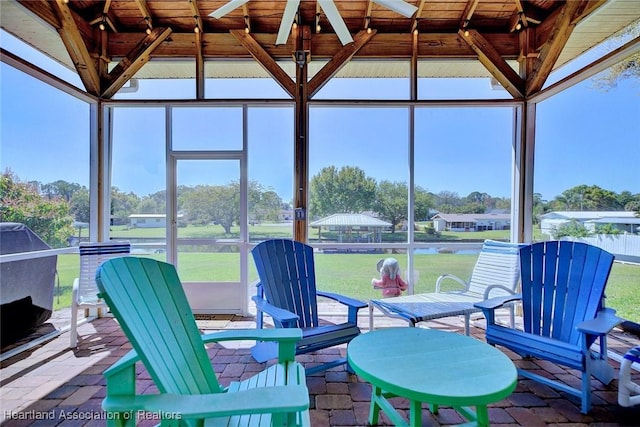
<box><xmin>13</xmin><ymin>0</ymin><xmax>605</xmax><ymax>99</ymax></box>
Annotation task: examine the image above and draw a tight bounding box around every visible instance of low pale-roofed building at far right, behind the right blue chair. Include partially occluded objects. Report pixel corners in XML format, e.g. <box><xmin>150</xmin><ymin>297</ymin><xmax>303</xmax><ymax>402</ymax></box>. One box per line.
<box><xmin>540</xmin><ymin>211</ymin><xmax>640</xmax><ymax>236</ymax></box>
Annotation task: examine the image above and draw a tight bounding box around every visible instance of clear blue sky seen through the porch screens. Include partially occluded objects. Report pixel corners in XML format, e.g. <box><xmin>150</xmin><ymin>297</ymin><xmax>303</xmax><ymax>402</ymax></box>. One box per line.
<box><xmin>0</xmin><ymin>33</ymin><xmax>640</xmax><ymax>204</ymax></box>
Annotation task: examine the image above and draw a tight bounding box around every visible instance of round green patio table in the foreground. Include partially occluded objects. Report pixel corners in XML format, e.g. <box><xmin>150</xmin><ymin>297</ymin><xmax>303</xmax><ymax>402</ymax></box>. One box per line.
<box><xmin>347</xmin><ymin>328</ymin><xmax>518</xmax><ymax>426</ymax></box>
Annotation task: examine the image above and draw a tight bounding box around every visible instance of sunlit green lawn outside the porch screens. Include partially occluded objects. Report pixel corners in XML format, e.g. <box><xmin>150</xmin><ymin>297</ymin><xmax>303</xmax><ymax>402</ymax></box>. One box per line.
<box><xmin>54</xmin><ymin>253</ymin><xmax>640</xmax><ymax>323</ymax></box>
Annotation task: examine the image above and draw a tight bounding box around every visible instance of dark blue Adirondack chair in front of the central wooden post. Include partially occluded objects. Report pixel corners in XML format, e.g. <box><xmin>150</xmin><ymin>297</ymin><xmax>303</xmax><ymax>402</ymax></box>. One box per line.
<box><xmin>251</xmin><ymin>239</ymin><xmax>367</xmax><ymax>374</ymax></box>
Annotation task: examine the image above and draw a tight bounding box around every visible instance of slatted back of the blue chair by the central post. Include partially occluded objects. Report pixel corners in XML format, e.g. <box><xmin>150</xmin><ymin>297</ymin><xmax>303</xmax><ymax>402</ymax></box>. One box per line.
<box><xmin>251</xmin><ymin>239</ymin><xmax>319</xmax><ymax>328</ymax></box>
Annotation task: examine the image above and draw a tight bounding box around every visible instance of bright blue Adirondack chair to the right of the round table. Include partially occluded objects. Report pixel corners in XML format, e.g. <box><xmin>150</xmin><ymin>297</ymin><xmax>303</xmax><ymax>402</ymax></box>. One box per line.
<box><xmin>475</xmin><ymin>241</ymin><xmax>622</xmax><ymax>414</ymax></box>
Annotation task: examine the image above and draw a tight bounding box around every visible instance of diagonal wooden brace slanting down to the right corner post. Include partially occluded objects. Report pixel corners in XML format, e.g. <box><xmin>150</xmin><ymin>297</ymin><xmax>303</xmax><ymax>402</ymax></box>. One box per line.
<box><xmin>458</xmin><ymin>29</ymin><xmax>524</xmax><ymax>99</ymax></box>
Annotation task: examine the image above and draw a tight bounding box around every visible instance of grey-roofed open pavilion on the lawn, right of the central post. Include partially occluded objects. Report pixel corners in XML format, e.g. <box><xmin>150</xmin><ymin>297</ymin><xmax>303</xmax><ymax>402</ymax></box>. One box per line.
<box><xmin>309</xmin><ymin>214</ymin><xmax>391</xmax><ymax>243</ymax></box>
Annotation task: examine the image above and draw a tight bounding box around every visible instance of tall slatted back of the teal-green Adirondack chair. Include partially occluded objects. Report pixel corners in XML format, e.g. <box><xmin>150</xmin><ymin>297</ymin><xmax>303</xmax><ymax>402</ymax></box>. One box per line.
<box><xmin>96</xmin><ymin>257</ymin><xmax>221</xmax><ymax>394</ymax></box>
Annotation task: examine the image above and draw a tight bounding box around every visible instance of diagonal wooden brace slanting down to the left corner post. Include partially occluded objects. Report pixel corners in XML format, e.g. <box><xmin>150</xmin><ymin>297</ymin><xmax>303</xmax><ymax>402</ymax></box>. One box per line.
<box><xmin>101</xmin><ymin>28</ymin><xmax>172</xmax><ymax>98</ymax></box>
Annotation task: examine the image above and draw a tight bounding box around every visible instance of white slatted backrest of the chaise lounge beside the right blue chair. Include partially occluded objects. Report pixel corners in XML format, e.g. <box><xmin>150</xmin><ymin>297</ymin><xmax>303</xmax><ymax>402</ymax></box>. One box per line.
<box><xmin>469</xmin><ymin>240</ymin><xmax>523</xmax><ymax>296</ymax></box>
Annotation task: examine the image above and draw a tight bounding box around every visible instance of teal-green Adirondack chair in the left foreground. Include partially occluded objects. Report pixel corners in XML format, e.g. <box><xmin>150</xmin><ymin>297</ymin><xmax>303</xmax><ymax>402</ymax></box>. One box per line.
<box><xmin>96</xmin><ymin>257</ymin><xmax>310</xmax><ymax>426</ymax></box>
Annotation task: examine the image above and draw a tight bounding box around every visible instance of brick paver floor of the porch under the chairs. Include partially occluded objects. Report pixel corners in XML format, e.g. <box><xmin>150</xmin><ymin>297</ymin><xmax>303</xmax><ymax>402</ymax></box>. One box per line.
<box><xmin>0</xmin><ymin>307</ymin><xmax>640</xmax><ymax>426</ymax></box>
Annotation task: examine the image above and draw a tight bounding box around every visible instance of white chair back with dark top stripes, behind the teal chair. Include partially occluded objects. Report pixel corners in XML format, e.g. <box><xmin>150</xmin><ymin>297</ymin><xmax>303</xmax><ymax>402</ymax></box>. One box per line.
<box><xmin>78</xmin><ymin>241</ymin><xmax>131</xmax><ymax>304</ymax></box>
